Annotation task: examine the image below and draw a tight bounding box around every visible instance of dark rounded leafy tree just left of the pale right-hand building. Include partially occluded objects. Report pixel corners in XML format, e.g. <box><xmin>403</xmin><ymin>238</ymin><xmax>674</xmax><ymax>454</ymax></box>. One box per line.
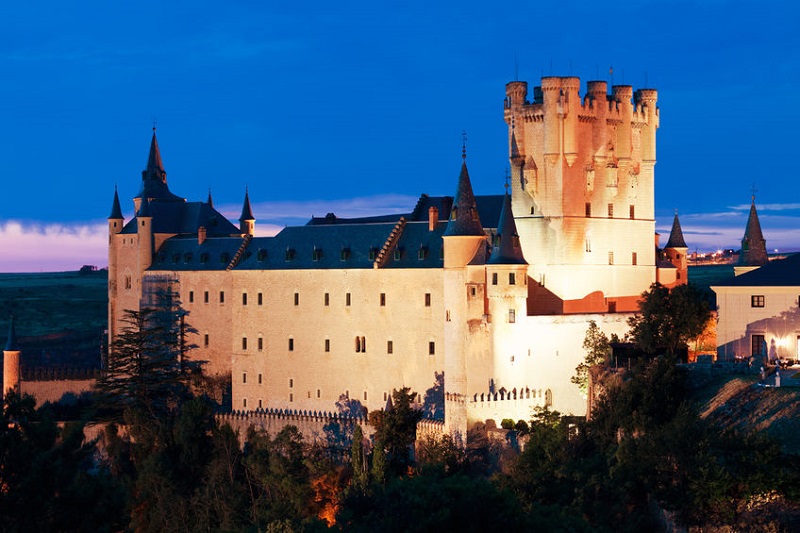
<box><xmin>628</xmin><ymin>283</ymin><xmax>711</xmax><ymax>354</ymax></box>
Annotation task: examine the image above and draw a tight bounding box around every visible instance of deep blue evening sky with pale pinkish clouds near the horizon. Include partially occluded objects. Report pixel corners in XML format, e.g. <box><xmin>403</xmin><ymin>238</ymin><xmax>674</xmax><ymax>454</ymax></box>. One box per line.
<box><xmin>0</xmin><ymin>0</ymin><xmax>800</xmax><ymax>271</ymax></box>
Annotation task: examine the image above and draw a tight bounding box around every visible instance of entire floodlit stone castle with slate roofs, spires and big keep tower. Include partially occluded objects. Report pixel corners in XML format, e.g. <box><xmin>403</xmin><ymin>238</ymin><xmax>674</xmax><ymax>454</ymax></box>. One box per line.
<box><xmin>108</xmin><ymin>77</ymin><xmax>687</xmax><ymax>434</ymax></box>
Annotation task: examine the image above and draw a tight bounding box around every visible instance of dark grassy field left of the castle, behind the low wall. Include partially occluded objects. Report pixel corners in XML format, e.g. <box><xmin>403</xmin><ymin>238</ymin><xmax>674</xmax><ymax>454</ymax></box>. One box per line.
<box><xmin>0</xmin><ymin>271</ymin><xmax>108</xmax><ymax>367</ymax></box>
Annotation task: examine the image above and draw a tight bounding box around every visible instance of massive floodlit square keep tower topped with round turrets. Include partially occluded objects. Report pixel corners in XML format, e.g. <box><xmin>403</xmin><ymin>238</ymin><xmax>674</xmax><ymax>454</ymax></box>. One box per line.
<box><xmin>505</xmin><ymin>76</ymin><xmax>659</xmax><ymax>314</ymax></box>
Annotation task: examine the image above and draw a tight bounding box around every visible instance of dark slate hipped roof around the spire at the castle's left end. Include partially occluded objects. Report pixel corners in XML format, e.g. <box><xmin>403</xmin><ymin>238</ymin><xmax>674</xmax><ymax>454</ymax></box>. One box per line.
<box><xmin>122</xmin><ymin>200</ymin><xmax>240</xmax><ymax>235</ymax></box>
